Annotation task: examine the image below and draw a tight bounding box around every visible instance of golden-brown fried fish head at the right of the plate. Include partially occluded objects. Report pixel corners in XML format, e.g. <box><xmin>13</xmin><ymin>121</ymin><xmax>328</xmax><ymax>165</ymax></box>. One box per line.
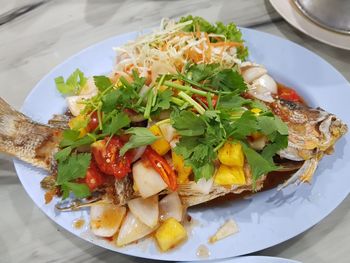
<box><xmin>269</xmin><ymin>99</ymin><xmax>348</xmax><ymax>161</ymax></box>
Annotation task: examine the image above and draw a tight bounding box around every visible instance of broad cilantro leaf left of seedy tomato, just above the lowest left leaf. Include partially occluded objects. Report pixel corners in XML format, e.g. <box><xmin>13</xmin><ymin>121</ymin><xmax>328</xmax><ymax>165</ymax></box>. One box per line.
<box><xmin>56</xmin><ymin>153</ymin><xmax>91</xmax><ymax>185</ymax></box>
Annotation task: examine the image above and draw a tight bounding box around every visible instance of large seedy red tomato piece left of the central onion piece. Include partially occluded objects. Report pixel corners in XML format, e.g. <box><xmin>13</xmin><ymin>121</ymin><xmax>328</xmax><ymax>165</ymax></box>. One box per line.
<box><xmin>91</xmin><ymin>136</ymin><xmax>133</xmax><ymax>179</ymax></box>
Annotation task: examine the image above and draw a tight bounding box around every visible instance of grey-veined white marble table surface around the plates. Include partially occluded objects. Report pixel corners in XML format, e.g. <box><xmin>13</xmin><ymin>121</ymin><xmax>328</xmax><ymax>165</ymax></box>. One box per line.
<box><xmin>0</xmin><ymin>0</ymin><xmax>350</xmax><ymax>263</ymax></box>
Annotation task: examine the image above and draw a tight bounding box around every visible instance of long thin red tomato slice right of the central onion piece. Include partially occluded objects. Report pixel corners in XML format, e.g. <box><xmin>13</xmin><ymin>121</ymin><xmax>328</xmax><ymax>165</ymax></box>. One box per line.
<box><xmin>144</xmin><ymin>146</ymin><xmax>177</xmax><ymax>191</ymax></box>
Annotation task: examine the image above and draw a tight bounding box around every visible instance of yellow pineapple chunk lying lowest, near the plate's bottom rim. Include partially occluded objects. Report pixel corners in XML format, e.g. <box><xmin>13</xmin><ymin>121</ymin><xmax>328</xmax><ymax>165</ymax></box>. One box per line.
<box><xmin>155</xmin><ymin>217</ymin><xmax>187</xmax><ymax>251</ymax></box>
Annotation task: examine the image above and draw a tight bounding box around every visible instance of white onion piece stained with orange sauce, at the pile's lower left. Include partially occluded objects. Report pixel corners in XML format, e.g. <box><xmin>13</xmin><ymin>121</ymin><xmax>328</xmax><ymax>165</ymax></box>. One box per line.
<box><xmin>90</xmin><ymin>204</ymin><xmax>126</xmax><ymax>237</ymax></box>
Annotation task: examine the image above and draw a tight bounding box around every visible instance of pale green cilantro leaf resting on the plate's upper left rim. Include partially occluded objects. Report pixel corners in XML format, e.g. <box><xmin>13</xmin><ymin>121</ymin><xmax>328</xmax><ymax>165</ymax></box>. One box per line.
<box><xmin>55</xmin><ymin>69</ymin><xmax>87</xmax><ymax>95</ymax></box>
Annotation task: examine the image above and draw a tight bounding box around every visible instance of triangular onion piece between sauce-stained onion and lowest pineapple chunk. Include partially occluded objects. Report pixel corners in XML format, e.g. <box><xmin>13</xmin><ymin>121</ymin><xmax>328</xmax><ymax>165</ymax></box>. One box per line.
<box><xmin>117</xmin><ymin>212</ymin><xmax>154</xmax><ymax>247</ymax></box>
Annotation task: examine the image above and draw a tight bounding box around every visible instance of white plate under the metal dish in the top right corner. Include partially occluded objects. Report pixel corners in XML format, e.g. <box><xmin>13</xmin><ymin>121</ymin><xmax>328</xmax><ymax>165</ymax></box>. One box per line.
<box><xmin>270</xmin><ymin>0</ymin><xmax>350</xmax><ymax>50</ymax></box>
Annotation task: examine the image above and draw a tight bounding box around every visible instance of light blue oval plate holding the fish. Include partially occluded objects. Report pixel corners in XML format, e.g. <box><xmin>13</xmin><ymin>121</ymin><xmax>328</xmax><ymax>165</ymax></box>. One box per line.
<box><xmin>15</xmin><ymin>29</ymin><xmax>350</xmax><ymax>261</ymax></box>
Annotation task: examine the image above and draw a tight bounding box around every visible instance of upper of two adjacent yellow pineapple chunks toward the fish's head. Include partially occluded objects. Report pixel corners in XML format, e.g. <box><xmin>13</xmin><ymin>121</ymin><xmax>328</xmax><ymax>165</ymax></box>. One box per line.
<box><xmin>218</xmin><ymin>142</ymin><xmax>244</xmax><ymax>167</ymax></box>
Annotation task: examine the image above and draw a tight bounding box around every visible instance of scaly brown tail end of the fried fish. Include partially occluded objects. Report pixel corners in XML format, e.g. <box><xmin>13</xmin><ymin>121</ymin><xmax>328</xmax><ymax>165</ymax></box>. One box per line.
<box><xmin>0</xmin><ymin>98</ymin><xmax>62</xmax><ymax>171</ymax></box>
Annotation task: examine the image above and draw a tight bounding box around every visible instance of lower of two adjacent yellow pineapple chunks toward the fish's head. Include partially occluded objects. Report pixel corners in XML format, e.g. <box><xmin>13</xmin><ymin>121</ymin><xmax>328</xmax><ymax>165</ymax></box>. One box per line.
<box><xmin>214</xmin><ymin>164</ymin><xmax>246</xmax><ymax>186</ymax></box>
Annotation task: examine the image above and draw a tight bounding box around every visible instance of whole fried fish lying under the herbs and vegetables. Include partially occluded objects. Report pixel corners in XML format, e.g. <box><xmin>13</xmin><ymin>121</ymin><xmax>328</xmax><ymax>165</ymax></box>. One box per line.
<box><xmin>0</xmin><ymin>98</ymin><xmax>347</xmax><ymax>207</ymax></box>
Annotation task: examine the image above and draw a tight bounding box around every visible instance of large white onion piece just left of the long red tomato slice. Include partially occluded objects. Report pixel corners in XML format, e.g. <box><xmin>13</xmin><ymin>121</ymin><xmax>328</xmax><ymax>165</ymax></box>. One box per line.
<box><xmin>132</xmin><ymin>160</ymin><xmax>167</xmax><ymax>198</ymax></box>
